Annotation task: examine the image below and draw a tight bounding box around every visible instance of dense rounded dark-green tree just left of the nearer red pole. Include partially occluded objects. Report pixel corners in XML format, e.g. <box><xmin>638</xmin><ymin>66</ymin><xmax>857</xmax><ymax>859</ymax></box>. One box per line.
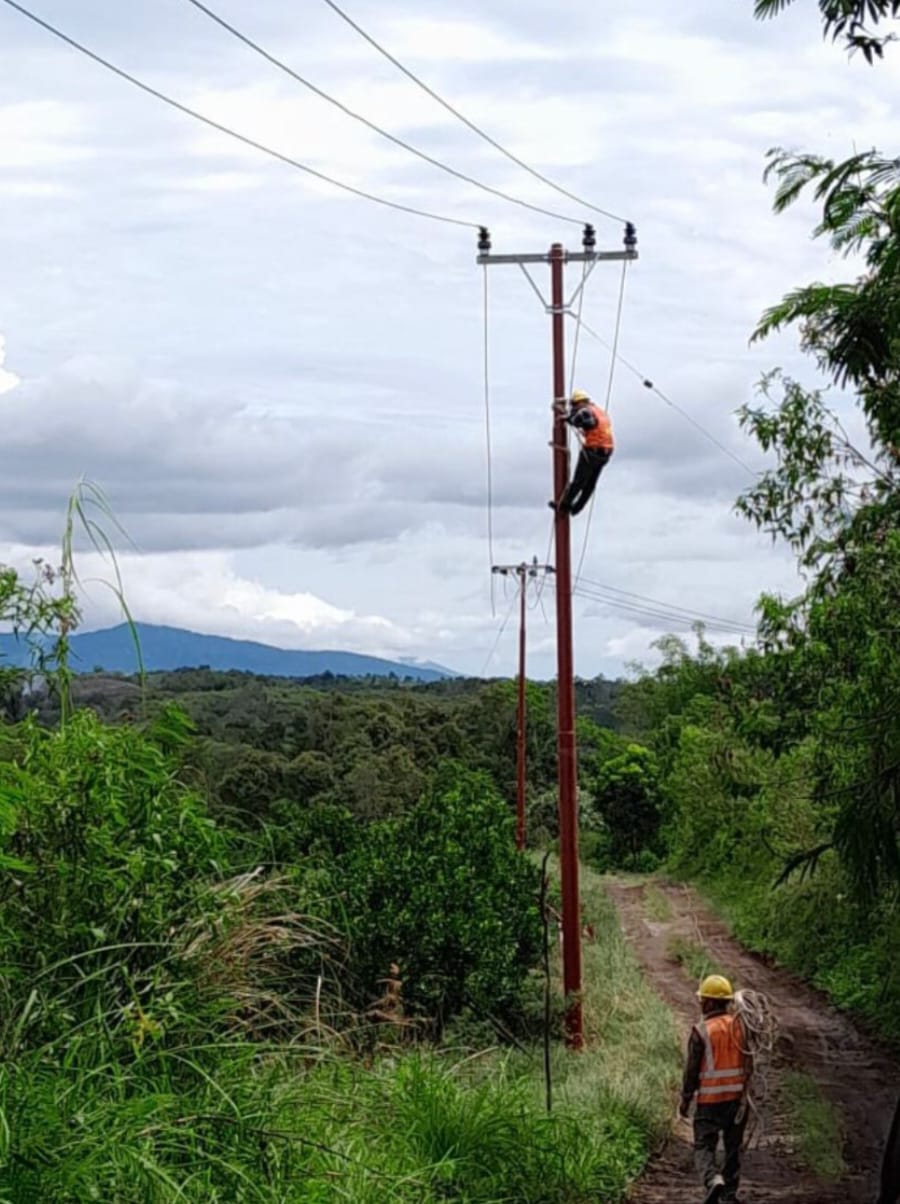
<box><xmin>333</xmin><ymin>765</ymin><xmax>540</xmax><ymax>1028</ymax></box>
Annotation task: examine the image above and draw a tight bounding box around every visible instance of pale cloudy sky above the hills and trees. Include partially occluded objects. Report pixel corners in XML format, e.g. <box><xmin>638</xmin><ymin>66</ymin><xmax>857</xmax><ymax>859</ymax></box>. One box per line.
<box><xmin>0</xmin><ymin>0</ymin><xmax>898</xmax><ymax>677</ymax></box>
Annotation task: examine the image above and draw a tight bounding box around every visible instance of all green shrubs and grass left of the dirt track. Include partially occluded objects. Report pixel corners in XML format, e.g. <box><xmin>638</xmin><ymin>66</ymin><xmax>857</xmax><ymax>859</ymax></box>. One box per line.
<box><xmin>0</xmin><ymin>529</ymin><xmax>677</xmax><ymax>1204</ymax></box>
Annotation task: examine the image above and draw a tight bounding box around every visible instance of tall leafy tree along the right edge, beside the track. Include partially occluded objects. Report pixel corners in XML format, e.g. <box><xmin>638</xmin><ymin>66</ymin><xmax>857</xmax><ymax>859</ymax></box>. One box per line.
<box><xmin>739</xmin><ymin>145</ymin><xmax>900</xmax><ymax>892</ymax></box>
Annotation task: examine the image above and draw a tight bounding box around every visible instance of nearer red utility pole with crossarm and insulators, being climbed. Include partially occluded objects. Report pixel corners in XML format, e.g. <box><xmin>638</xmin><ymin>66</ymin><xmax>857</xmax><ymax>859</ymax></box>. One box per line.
<box><xmin>478</xmin><ymin>222</ymin><xmax>638</xmax><ymax>1049</ymax></box>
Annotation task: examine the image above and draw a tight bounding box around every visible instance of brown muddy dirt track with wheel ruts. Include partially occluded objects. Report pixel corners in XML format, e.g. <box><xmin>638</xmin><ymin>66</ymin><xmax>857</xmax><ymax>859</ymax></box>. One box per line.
<box><xmin>609</xmin><ymin>881</ymin><xmax>900</xmax><ymax>1204</ymax></box>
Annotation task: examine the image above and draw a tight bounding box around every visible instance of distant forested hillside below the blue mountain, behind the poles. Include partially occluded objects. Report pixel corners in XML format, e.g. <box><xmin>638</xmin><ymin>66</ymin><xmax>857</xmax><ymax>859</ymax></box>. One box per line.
<box><xmin>7</xmin><ymin>669</ymin><xmax>618</xmax><ymax>832</ymax></box>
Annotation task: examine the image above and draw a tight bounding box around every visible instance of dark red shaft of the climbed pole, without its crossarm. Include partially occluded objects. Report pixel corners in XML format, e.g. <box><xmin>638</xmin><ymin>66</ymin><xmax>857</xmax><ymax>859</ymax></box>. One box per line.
<box><xmin>550</xmin><ymin>242</ymin><xmax>585</xmax><ymax>1049</ymax></box>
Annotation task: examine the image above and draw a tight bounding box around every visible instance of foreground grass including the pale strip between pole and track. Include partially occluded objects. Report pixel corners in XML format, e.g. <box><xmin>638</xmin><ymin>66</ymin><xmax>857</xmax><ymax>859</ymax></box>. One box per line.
<box><xmin>0</xmin><ymin>857</ymin><xmax>677</xmax><ymax>1204</ymax></box>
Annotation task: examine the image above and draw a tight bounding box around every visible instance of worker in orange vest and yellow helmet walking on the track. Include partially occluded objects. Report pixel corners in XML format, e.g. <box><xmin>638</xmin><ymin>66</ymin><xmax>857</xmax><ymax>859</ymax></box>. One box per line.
<box><xmin>679</xmin><ymin>974</ymin><xmax>753</xmax><ymax>1204</ymax></box>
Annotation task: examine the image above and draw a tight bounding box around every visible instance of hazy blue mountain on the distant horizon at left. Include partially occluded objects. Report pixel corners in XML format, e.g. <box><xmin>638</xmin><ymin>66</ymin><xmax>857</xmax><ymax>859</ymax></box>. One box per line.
<box><xmin>0</xmin><ymin>622</ymin><xmax>458</xmax><ymax>681</ymax></box>
